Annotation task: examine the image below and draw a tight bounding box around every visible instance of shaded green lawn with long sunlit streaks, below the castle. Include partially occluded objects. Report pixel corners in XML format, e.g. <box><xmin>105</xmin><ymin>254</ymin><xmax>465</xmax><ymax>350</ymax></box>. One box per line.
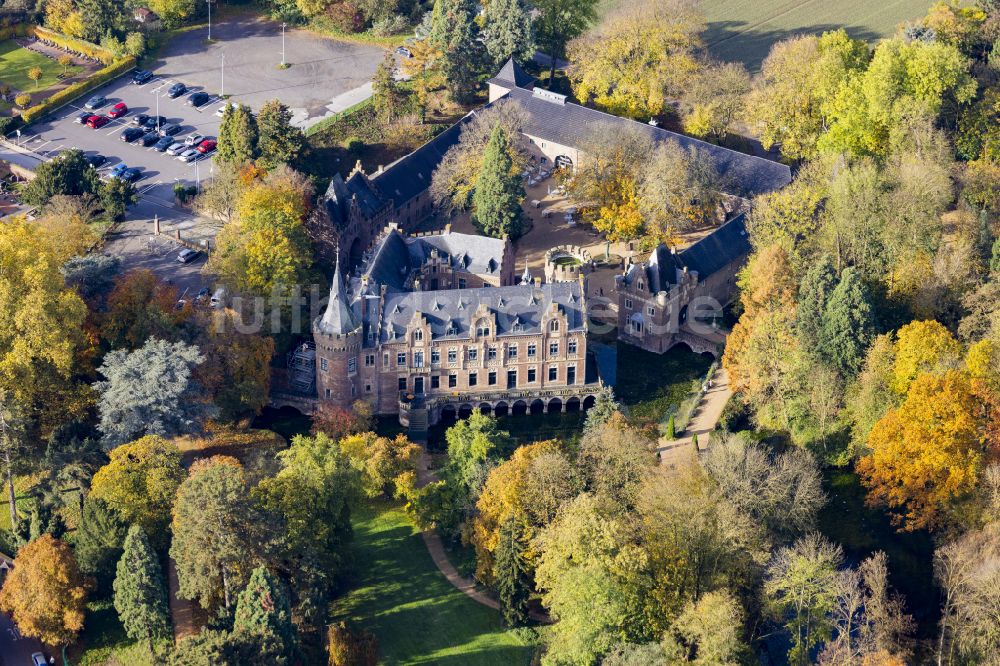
<box><xmin>333</xmin><ymin>504</ymin><xmax>534</xmax><ymax>666</ymax></box>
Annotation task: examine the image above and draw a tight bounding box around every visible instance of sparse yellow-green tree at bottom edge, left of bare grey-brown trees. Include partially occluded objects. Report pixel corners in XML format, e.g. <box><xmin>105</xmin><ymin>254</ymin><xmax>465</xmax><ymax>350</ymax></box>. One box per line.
<box><xmin>764</xmin><ymin>533</ymin><xmax>844</xmax><ymax>665</ymax></box>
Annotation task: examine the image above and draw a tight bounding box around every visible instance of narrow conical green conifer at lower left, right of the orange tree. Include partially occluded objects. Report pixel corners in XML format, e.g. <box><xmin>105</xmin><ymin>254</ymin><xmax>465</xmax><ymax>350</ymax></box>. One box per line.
<box><xmin>115</xmin><ymin>525</ymin><xmax>170</xmax><ymax>652</ymax></box>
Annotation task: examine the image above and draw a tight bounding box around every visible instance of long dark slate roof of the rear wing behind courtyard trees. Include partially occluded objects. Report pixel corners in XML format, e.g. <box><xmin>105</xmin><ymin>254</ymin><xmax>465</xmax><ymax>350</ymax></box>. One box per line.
<box><xmin>505</xmin><ymin>87</ymin><xmax>792</xmax><ymax>197</ymax></box>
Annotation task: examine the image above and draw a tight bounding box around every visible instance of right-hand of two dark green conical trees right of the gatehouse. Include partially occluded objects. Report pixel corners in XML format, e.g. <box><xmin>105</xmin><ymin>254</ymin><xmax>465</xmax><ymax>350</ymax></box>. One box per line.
<box><xmin>820</xmin><ymin>267</ymin><xmax>875</xmax><ymax>377</ymax></box>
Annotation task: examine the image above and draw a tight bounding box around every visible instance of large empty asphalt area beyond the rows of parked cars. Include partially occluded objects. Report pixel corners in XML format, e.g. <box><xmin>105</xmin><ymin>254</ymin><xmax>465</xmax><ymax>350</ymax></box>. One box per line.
<box><xmin>150</xmin><ymin>12</ymin><xmax>384</xmax><ymax>129</ymax></box>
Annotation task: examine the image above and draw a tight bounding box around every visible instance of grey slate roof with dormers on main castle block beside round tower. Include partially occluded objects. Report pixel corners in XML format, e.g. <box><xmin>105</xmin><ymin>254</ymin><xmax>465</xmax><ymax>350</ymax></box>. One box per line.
<box><xmin>379</xmin><ymin>282</ymin><xmax>585</xmax><ymax>342</ymax></box>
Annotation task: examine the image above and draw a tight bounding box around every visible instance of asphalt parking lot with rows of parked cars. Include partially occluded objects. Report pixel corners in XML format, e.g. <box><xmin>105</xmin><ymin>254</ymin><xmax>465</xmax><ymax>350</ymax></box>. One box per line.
<box><xmin>11</xmin><ymin>74</ymin><xmax>223</xmax><ymax>205</ymax></box>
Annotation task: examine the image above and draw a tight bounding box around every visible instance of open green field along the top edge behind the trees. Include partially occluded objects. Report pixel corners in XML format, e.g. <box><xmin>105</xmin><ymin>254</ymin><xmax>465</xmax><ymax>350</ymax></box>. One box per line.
<box><xmin>602</xmin><ymin>0</ymin><xmax>932</xmax><ymax>71</ymax></box>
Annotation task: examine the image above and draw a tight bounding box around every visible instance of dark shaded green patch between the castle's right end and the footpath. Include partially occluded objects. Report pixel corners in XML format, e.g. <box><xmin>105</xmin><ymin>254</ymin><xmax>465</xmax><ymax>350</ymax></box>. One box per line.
<box><xmin>615</xmin><ymin>344</ymin><xmax>712</xmax><ymax>434</ymax></box>
